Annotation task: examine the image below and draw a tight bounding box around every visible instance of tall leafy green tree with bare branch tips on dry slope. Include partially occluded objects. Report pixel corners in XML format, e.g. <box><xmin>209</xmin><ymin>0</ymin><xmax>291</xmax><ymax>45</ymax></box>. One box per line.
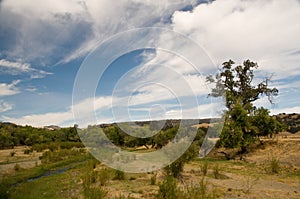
<box><xmin>207</xmin><ymin>60</ymin><xmax>280</xmax><ymax>151</ymax></box>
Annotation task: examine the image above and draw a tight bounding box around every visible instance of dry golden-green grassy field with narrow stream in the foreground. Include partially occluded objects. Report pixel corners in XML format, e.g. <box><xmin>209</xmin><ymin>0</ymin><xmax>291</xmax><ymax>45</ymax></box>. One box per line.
<box><xmin>0</xmin><ymin>138</ymin><xmax>300</xmax><ymax>199</ymax></box>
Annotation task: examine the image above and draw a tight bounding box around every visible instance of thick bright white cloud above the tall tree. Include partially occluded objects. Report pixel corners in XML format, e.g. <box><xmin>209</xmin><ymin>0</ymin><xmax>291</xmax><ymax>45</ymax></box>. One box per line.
<box><xmin>172</xmin><ymin>0</ymin><xmax>300</xmax><ymax>75</ymax></box>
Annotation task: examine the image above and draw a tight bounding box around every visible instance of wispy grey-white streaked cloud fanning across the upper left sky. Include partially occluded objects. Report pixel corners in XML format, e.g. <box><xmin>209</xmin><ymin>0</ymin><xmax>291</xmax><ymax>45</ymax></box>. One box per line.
<box><xmin>0</xmin><ymin>0</ymin><xmax>200</xmax><ymax>64</ymax></box>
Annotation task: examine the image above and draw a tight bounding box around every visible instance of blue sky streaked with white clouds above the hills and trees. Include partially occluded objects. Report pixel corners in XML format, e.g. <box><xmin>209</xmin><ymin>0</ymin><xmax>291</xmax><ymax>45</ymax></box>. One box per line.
<box><xmin>0</xmin><ymin>0</ymin><xmax>300</xmax><ymax>127</ymax></box>
